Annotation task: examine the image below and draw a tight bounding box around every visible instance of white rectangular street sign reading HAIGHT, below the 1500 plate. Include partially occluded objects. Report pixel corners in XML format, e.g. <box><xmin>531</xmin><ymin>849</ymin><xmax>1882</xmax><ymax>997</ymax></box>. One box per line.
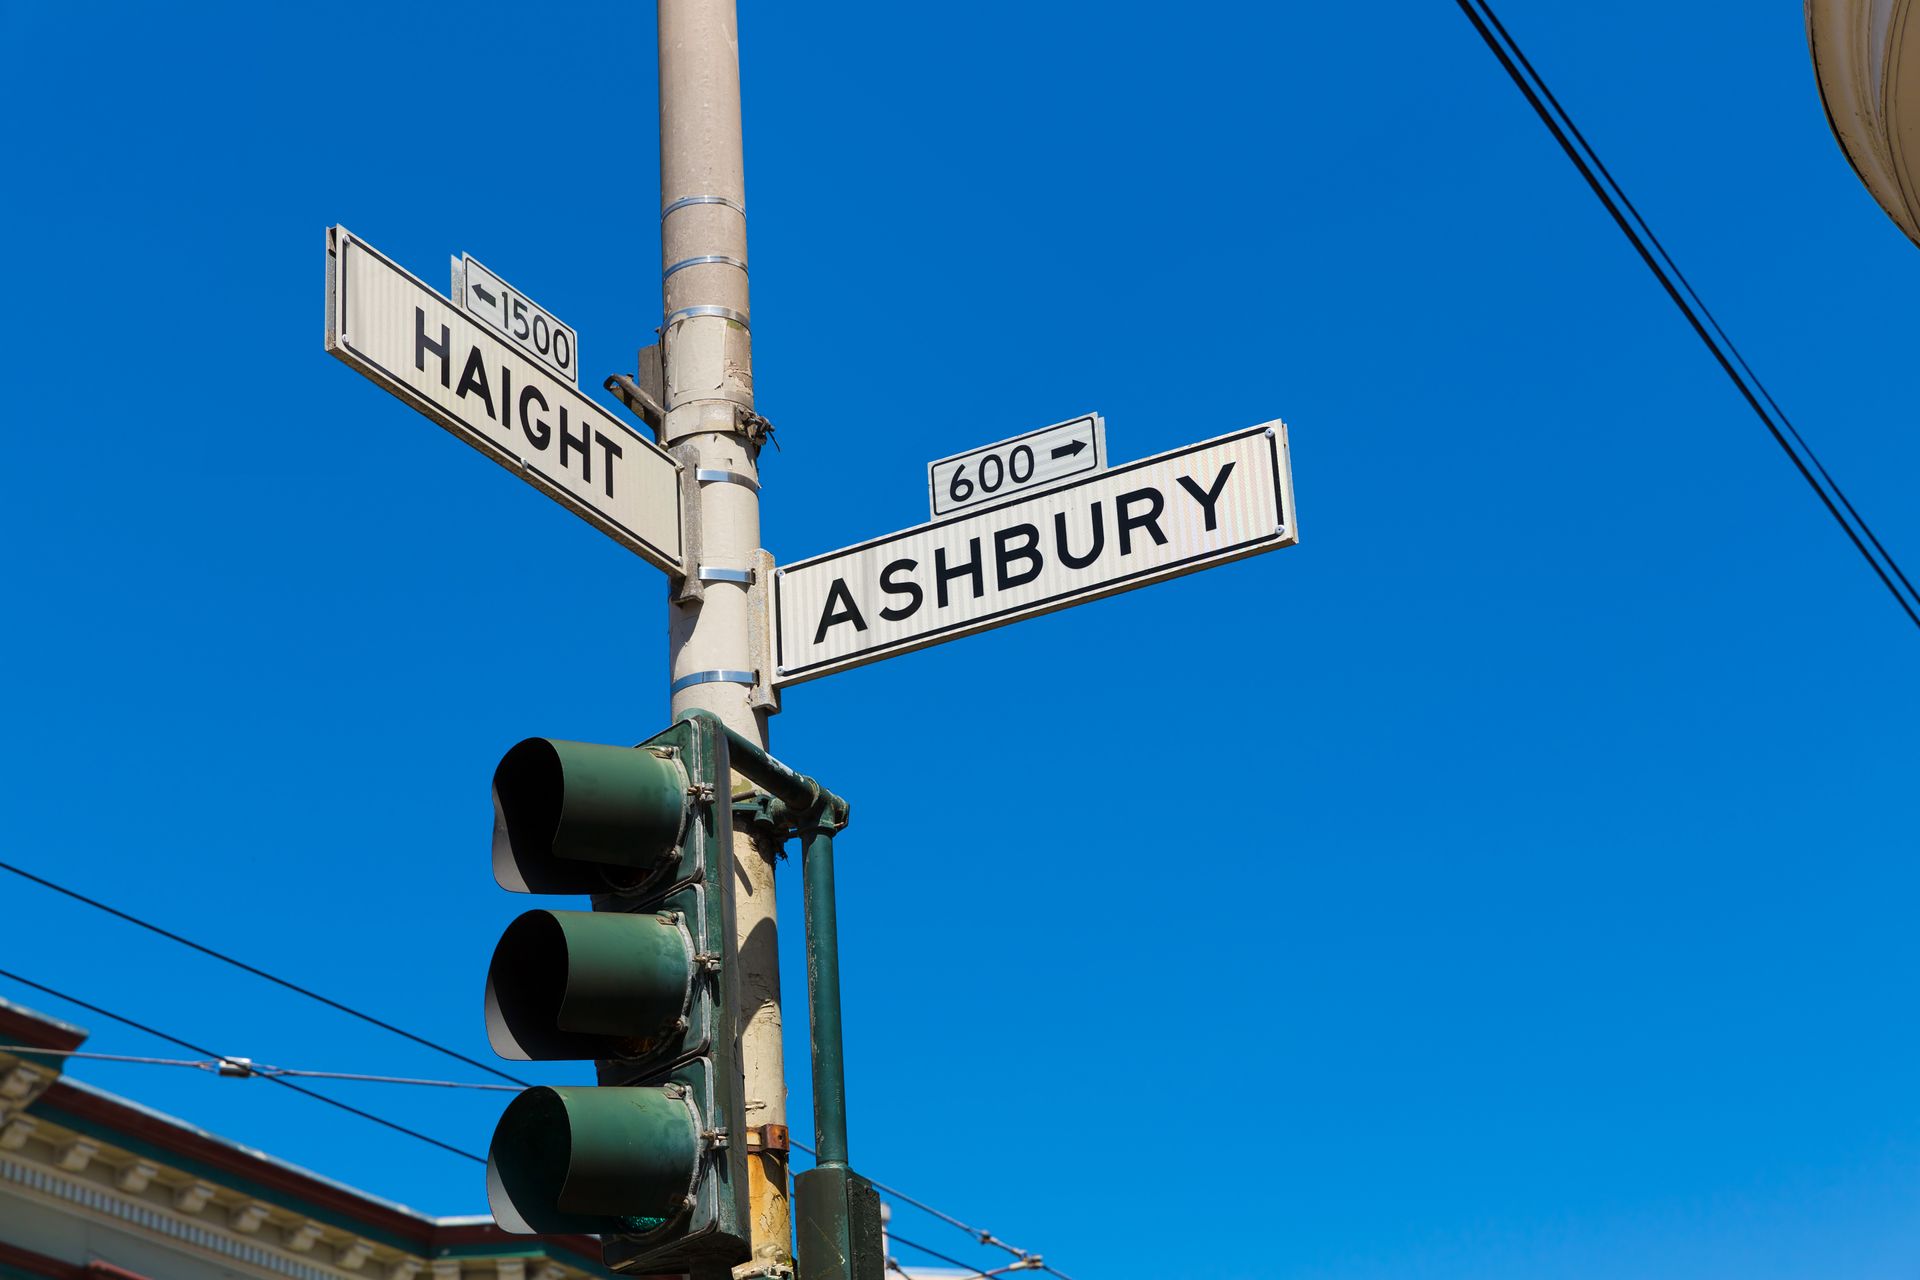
<box><xmin>326</xmin><ymin>226</ymin><xmax>685</xmax><ymax>574</ymax></box>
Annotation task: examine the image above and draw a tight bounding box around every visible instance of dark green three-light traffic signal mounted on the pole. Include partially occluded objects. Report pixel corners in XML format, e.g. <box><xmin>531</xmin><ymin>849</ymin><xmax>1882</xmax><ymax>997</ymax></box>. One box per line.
<box><xmin>486</xmin><ymin>716</ymin><xmax>751</xmax><ymax>1274</ymax></box>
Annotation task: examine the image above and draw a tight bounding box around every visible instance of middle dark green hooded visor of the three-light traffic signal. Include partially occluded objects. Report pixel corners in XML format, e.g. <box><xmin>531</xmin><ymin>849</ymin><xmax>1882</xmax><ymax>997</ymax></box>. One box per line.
<box><xmin>486</xmin><ymin>912</ymin><xmax>695</xmax><ymax>1061</ymax></box>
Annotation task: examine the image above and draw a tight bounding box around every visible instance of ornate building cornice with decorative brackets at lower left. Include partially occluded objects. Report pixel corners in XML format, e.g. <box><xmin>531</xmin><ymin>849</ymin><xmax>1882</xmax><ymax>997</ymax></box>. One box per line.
<box><xmin>0</xmin><ymin>1002</ymin><xmax>611</xmax><ymax>1280</ymax></box>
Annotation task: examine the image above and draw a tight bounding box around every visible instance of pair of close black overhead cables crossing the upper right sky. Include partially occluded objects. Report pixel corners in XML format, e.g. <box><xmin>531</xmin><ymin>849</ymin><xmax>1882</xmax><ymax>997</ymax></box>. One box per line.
<box><xmin>1455</xmin><ymin>0</ymin><xmax>1920</xmax><ymax>628</ymax></box>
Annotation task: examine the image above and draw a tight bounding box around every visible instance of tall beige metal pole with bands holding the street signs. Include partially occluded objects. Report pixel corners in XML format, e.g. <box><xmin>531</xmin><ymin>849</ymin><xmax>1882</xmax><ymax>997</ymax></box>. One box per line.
<box><xmin>659</xmin><ymin>0</ymin><xmax>793</xmax><ymax>1270</ymax></box>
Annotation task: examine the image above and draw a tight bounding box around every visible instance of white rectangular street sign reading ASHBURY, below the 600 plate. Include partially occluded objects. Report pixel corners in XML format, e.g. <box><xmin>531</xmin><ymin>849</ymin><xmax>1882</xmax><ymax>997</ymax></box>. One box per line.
<box><xmin>772</xmin><ymin>422</ymin><xmax>1298</xmax><ymax>685</ymax></box>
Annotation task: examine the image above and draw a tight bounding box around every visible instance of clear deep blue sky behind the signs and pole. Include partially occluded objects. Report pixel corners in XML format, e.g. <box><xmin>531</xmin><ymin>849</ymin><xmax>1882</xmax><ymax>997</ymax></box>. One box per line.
<box><xmin>0</xmin><ymin>0</ymin><xmax>1920</xmax><ymax>1280</ymax></box>
